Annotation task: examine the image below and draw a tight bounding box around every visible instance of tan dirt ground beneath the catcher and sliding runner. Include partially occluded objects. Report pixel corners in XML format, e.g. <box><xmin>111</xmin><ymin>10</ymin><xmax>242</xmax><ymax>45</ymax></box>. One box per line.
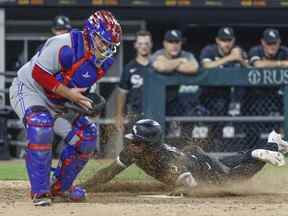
<box><xmin>0</xmin><ymin>179</ymin><xmax>288</xmax><ymax>216</ymax></box>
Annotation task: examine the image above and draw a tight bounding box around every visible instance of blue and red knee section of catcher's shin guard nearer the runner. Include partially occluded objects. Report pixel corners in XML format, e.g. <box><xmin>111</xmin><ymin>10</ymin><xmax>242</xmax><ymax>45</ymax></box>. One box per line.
<box><xmin>65</xmin><ymin>116</ymin><xmax>97</xmax><ymax>155</ymax></box>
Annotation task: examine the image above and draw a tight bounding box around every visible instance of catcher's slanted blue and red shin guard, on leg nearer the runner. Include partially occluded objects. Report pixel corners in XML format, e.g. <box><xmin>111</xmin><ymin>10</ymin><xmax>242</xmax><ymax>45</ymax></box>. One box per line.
<box><xmin>51</xmin><ymin>116</ymin><xmax>97</xmax><ymax>195</ymax></box>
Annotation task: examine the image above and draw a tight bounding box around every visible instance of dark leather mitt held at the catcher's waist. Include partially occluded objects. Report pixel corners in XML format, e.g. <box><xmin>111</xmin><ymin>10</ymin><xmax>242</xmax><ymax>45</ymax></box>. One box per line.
<box><xmin>64</xmin><ymin>93</ymin><xmax>106</xmax><ymax>117</ymax></box>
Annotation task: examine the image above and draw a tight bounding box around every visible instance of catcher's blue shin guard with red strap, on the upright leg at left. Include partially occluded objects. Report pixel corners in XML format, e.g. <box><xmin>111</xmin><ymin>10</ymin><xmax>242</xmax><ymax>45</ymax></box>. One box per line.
<box><xmin>24</xmin><ymin>106</ymin><xmax>54</xmax><ymax>197</ymax></box>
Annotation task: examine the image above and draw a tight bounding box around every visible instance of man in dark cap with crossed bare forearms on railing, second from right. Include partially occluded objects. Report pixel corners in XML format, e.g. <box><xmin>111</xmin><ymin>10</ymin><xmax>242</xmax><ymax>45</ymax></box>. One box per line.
<box><xmin>199</xmin><ymin>27</ymin><xmax>248</xmax><ymax>151</ymax></box>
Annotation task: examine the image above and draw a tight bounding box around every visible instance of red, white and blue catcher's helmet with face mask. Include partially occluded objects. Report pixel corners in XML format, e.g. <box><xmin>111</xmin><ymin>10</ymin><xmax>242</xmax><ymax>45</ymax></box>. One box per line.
<box><xmin>83</xmin><ymin>10</ymin><xmax>122</xmax><ymax>57</ymax></box>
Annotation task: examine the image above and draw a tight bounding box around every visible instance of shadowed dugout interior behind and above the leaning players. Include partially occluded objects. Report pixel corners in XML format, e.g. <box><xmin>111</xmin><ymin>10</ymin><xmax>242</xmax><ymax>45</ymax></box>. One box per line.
<box><xmin>0</xmin><ymin>0</ymin><xmax>288</xmax><ymax>159</ymax></box>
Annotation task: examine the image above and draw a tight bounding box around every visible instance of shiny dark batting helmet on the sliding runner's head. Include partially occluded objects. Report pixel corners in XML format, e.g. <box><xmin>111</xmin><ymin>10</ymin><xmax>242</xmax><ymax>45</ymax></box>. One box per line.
<box><xmin>125</xmin><ymin>119</ymin><xmax>162</xmax><ymax>143</ymax></box>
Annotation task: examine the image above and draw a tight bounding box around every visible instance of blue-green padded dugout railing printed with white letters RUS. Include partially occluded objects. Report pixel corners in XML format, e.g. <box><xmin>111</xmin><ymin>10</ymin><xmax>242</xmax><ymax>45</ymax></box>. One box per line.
<box><xmin>143</xmin><ymin>68</ymin><xmax>288</xmax><ymax>149</ymax></box>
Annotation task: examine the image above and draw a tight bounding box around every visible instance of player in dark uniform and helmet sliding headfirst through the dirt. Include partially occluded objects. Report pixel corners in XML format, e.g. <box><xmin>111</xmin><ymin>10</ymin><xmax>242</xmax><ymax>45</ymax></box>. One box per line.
<box><xmin>84</xmin><ymin>119</ymin><xmax>288</xmax><ymax>195</ymax></box>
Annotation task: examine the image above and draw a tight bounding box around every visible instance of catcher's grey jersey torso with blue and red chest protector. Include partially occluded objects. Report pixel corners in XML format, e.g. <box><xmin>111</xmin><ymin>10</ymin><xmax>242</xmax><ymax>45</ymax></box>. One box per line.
<box><xmin>17</xmin><ymin>31</ymin><xmax>113</xmax><ymax>103</ymax></box>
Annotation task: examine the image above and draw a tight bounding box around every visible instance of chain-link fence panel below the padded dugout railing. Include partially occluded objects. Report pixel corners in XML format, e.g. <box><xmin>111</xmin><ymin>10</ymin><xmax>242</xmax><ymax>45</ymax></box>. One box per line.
<box><xmin>166</xmin><ymin>86</ymin><xmax>284</xmax><ymax>152</ymax></box>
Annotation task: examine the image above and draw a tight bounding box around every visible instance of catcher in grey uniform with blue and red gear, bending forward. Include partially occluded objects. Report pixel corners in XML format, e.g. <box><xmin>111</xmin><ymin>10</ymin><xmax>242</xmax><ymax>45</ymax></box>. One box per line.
<box><xmin>9</xmin><ymin>10</ymin><xmax>122</xmax><ymax>206</ymax></box>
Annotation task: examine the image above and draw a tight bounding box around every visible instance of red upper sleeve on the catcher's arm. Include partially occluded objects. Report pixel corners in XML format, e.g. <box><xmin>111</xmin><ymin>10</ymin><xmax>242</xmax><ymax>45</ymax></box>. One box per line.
<box><xmin>32</xmin><ymin>64</ymin><xmax>61</xmax><ymax>91</ymax></box>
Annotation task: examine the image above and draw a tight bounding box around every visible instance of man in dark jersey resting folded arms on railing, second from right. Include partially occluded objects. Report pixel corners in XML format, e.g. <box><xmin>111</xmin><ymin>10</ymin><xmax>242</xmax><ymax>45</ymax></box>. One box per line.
<box><xmin>200</xmin><ymin>27</ymin><xmax>248</xmax><ymax>115</ymax></box>
